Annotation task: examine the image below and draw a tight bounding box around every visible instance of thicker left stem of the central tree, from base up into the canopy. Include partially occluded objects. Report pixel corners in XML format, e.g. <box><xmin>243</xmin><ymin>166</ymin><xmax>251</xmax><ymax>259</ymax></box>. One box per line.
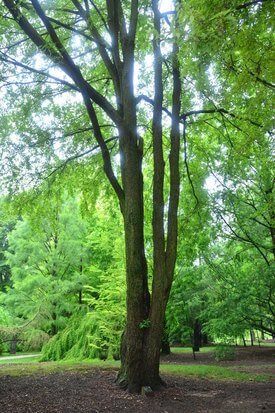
<box><xmin>115</xmin><ymin>16</ymin><xmax>153</xmax><ymax>392</ymax></box>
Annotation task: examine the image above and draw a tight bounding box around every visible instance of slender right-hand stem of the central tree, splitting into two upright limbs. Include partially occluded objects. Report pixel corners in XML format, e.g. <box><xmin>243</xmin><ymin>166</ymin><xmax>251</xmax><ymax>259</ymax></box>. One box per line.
<box><xmin>134</xmin><ymin>0</ymin><xmax>181</xmax><ymax>389</ymax></box>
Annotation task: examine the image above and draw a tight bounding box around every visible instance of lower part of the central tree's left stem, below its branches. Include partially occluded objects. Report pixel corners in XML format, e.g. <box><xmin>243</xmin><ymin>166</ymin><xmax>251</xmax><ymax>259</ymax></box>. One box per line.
<box><xmin>116</xmin><ymin>137</ymin><xmax>150</xmax><ymax>392</ymax></box>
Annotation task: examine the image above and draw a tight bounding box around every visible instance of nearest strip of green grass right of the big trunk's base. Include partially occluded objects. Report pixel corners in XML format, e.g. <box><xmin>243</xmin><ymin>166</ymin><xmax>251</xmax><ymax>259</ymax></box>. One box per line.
<box><xmin>160</xmin><ymin>364</ymin><xmax>271</xmax><ymax>382</ymax></box>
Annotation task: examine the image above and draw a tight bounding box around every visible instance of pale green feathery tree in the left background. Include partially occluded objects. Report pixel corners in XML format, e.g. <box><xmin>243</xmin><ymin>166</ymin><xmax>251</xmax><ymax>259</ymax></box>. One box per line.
<box><xmin>2</xmin><ymin>199</ymin><xmax>90</xmax><ymax>335</ymax></box>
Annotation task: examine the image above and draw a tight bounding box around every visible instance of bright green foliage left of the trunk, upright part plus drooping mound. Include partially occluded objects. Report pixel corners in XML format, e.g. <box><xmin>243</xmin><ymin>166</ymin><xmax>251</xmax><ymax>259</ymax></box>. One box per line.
<box><xmin>43</xmin><ymin>195</ymin><xmax>126</xmax><ymax>360</ymax></box>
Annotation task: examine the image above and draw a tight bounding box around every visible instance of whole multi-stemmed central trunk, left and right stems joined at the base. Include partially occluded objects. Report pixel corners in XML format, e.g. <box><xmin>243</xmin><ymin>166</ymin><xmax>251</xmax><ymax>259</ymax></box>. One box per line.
<box><xmin>119</xmin><ymin>0</ymin><xmax>181</xmax><ymax>392</ymax></box>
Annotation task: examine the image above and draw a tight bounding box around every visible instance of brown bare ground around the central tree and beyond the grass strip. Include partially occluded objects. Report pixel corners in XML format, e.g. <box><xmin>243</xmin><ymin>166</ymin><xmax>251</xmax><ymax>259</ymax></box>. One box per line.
<box><xmin>0</xmin><ymin>348</ymin><xmax>275</xmax><ymax>413</ymax></box>
